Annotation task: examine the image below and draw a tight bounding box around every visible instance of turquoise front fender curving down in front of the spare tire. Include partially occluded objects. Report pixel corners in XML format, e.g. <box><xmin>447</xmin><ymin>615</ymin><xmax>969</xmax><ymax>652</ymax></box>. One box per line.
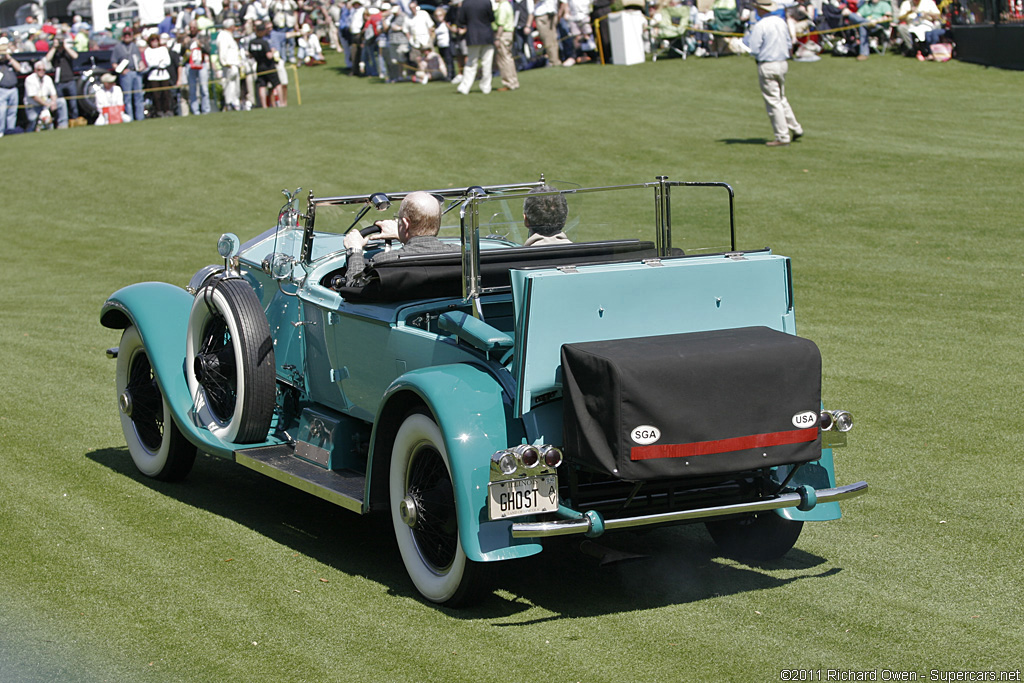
<box><xmin>99</xmin><ymin>283</ymin><xmax>233</xmax><ymax>458</ymax></box>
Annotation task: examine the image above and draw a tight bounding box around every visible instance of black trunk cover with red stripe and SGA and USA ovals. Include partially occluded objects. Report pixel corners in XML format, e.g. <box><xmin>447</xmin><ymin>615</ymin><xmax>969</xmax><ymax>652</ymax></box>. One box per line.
<box><xmin>561</xmin><ymin>328</ymin><xmax>821</xmax><ymax>481</ymax></box>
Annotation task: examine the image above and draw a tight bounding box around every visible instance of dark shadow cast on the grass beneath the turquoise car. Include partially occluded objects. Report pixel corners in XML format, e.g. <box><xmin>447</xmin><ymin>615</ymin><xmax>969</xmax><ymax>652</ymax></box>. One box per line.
<box><xmin>87</xmin><ymin>447</ymin><xmax>842</xmax><ymax>627</ymax></box>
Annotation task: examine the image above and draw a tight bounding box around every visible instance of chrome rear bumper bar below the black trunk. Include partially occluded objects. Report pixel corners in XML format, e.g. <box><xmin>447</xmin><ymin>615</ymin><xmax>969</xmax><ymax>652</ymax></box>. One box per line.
<box><xmin>512</xmin><ymin>481</ymin><xmax>867</xmax><ymax>539</ymax></box>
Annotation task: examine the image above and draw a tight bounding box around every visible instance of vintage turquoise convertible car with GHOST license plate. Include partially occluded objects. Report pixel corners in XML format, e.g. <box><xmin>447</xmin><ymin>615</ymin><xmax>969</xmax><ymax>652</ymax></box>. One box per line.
<box><xmin>100</xmin><ymin>176</ymin><xmax>867</xmax><ymax>606</ymax></box>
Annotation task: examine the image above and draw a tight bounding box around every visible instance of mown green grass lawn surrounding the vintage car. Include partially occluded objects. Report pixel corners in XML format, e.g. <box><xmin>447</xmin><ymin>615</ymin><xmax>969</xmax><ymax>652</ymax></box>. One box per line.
<box><xmin>0</xmin><ymin>55</ymin><xmax>1024</xmax><ymax>683</ymax></box>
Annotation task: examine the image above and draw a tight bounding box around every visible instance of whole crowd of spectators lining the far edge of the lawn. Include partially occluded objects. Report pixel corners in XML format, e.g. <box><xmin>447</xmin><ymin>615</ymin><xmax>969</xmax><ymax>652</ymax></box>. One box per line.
<box><xmin>0</xmin><ymin>0</ymin><xmax>958</xmax><ymax>135</ymax></box>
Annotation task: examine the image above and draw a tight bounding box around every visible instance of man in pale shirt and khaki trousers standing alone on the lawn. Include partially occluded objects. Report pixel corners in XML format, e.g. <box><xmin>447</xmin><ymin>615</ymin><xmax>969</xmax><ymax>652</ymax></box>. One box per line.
<box><xmin>749</xmin><ymin>0</ymin><xmax>804</xmax><ymax>147</ymax></box>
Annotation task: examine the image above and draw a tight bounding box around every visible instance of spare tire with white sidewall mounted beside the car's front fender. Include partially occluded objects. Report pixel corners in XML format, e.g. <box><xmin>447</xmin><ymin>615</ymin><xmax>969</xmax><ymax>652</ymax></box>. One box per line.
<box><xmin>185</xmin><ymin>278</ymin><xmax>275</xmax><ymax>443</ymax></box>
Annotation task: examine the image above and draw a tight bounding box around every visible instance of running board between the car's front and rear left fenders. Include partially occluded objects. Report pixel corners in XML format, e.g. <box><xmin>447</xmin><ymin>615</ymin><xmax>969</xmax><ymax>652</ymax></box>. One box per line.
<box><xmin>234</xmin><ymin>445</ymin><xmax>367</xmax><ymax>513</ymax></box>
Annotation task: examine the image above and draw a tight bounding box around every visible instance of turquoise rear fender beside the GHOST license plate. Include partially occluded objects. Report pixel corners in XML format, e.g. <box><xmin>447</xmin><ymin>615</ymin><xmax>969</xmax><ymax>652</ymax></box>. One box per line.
<box><xmin>373</xmin><ymin>365</ymin><xmax>542</xmax><ymax>562</ymax></box>
